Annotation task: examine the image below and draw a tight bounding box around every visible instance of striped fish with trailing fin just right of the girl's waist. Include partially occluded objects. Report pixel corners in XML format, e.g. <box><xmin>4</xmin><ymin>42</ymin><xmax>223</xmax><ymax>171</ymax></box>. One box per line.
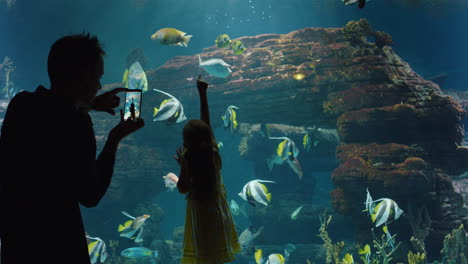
<box><xmin>239</xmin><ymin>180</ymin><xmax>276</xmax><ymax>207</ymax></box>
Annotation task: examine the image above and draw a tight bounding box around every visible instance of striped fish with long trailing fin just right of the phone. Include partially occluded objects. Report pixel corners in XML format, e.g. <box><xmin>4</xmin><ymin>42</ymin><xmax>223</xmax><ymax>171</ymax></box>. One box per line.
<box><xmin>153</xmin><ymin>89</ymin><xmax>187</xmax><ymax>125</ymax></box>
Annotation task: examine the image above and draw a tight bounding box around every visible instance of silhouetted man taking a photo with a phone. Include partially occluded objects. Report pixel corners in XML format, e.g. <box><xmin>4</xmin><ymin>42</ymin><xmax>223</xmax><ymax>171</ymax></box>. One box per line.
<box><xmin>0</xmin><ymin>34</ymin><xmax>144</xmax><ymax>264</ymax></box>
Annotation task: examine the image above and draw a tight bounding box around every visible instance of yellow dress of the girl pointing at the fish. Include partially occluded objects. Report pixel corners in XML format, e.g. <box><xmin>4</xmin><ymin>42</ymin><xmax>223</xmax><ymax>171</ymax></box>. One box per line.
<box><xmin>181</xmin><ymin>150</ymin><xmax>241</xmax><ymax>264</ymax></box>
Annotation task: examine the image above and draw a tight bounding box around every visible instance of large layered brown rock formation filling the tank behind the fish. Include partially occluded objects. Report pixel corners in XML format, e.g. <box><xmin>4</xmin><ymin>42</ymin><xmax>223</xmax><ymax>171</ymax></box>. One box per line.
<box><xmin>91</xmin><ymin>23</ymin><xmax>468</xmax><ymax>252</ymax></box>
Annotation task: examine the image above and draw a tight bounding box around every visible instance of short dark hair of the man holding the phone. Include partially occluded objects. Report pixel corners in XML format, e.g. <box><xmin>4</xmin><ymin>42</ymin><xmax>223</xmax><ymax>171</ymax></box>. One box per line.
<box><xmin>47</xmin><ymin>33</ymin><xmax>105</xmax><ymax>83</ymax></box>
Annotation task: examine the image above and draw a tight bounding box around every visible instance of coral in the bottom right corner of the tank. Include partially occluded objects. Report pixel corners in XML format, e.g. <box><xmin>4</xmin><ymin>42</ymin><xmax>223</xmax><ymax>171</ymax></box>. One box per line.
<box><xmin>440</xmin><ymin>224</ymin><xmax>468</xmax><ymax>264</ymax></box>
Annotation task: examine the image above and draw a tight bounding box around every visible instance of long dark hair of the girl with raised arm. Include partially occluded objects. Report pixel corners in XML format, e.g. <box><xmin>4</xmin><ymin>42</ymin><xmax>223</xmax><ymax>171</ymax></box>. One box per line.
<box><xmin>183</xmin><ymin>119</ymin><xmax>217</xmax><ymax>199</ymax></box>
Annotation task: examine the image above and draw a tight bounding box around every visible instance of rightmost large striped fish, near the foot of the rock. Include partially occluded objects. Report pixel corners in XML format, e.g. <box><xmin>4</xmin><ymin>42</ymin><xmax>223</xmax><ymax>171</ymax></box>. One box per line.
<box><xmin>365</xmin><ymin>189</ymin><xmax>403</xmax><ymax>227</ymax></box>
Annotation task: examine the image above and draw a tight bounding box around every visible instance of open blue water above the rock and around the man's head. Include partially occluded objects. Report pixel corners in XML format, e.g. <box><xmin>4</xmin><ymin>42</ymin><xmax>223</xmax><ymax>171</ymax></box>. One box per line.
<box><xmin>0</xmin><ymin>0</ymin><xmax>468</xmax><ymax>90</ymax></box>
